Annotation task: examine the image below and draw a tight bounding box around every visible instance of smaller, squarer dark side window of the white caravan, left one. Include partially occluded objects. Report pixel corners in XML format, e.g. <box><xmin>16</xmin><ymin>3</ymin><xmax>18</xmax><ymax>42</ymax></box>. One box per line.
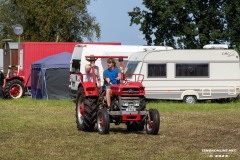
<box><xmin>148</xmin><ymin>64</ymin><xmax>167</xmax><ymax>78</ymax></box>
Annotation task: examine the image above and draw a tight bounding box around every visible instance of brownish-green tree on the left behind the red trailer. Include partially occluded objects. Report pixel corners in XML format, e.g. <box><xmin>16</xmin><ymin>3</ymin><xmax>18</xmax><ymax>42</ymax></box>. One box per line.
<box><xmin>0</xmin><ymin>0</ymin><xmax>100</xmax><ymax>42</ymax></box>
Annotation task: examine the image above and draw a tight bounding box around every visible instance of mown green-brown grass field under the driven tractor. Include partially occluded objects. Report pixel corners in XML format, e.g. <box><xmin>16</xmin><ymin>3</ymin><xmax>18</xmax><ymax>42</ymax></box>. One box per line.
<box><xmin>0</xmin><ymin>97</ymin><xmax>240</xmax><ymax>160</ymax></box>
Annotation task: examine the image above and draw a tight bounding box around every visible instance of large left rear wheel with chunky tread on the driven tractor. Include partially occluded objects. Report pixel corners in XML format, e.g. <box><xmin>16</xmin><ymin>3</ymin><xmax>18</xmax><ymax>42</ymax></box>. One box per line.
<box><xmin>76</xmin><ymin>88</ymin><xmax>97</xmax><ymax>131</ymax></box>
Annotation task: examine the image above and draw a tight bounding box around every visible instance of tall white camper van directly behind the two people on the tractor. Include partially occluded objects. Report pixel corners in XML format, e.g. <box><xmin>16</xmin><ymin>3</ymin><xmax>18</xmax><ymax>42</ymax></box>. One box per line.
<box><xmin>69</xmin><ymin>44</ymin><xmax>173</xmax><ymax>97</ymax></box>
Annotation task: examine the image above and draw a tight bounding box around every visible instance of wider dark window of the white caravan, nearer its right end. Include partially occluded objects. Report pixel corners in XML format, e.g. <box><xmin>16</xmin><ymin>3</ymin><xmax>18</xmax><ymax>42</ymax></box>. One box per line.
<box><xmin>176</xmin><ymin>64</ymin><xmax>209</xmax><ymax>77</ymax></box>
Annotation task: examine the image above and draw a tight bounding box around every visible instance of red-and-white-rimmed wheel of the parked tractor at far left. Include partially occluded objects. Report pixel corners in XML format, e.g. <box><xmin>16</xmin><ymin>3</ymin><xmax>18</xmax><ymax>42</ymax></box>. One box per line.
<box><xmin>4</xmin><ymin>79</ymin><xmax>24</xmax><ymax>99</ymax></box>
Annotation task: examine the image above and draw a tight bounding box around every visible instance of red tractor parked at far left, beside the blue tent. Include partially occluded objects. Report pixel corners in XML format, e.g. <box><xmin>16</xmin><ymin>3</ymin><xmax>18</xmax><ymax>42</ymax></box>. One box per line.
<box><xmin>4</xmin><ymin>66</ymin><xmax>25</xmax><ymax>99</ymax></box>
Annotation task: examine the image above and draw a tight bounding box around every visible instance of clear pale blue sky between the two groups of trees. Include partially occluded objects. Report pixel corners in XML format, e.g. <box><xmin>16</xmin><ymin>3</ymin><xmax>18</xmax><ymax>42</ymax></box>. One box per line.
<box><xmin>88</xmin><ymin>0</ymin><xmax>146</xmax><ymax>45</ymax></box>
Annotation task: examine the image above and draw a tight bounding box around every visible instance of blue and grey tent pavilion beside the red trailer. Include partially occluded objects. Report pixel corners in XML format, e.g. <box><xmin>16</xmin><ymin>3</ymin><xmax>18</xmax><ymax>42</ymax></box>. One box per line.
<box><xmin>31</xmin><ymin>52</ymin><xmax>72</xmax><ymax>99</ymax></box>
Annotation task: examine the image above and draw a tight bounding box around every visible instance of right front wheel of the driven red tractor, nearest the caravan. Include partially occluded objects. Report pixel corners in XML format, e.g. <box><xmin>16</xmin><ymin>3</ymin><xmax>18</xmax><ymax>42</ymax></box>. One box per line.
<box><xmin>146</xmin><ymin>109</ymin><xmax>160</xmax><ymax>135</ymax></box>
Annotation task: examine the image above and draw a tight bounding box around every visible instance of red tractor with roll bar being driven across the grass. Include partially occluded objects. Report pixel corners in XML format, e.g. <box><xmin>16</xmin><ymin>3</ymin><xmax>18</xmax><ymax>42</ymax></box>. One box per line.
<box><xmin>76</xmin><ymin>56</ymin><xmax>160</xmax><ymax>135</ymax></box>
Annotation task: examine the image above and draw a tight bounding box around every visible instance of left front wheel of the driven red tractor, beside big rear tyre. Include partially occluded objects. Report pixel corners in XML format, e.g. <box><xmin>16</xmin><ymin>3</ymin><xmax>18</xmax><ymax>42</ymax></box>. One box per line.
<box><xmin>97</xmin><ymin>108</ymin><xmax>110</xmax><ymax>134</ymax></box>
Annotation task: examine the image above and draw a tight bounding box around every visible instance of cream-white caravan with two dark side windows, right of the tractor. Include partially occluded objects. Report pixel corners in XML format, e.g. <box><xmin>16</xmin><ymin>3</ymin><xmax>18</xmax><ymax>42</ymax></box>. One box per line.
<box><xmin>125</xmin><ymin>49</ymin><xmax>240</xmax><ymax>103</ymax></box>
